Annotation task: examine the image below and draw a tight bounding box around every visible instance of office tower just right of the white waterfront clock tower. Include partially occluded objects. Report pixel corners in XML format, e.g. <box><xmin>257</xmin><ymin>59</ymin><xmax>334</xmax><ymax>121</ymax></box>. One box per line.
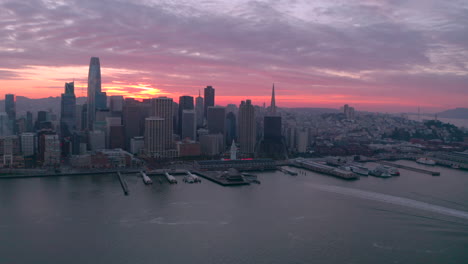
<box><xmin>238</xmin><ymin>100</ymin><xmax>256</xmax><ymax>154</ymax></box>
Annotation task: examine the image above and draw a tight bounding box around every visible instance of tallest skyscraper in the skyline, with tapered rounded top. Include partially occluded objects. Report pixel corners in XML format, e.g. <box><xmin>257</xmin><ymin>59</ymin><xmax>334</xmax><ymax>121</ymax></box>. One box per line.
<box><xmin>87</xmin><ymin>57</ymin><xmax>107</xmax><ymax>130</ymax></box>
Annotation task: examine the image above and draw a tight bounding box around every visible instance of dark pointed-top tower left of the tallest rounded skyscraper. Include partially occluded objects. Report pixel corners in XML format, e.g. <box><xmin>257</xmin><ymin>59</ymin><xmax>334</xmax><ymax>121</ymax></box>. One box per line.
<box><xmin>60</xmin><ymin>82</ymin><xmax>76</xmax><ymax>138</ymax></box>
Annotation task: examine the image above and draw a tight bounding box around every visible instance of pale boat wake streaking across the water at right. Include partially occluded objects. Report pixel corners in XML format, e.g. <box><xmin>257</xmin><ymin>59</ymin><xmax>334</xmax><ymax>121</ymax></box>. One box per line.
<box><xmin>310</xmin><ymin>184</ymin><xmax>468</xmax><ymax>223</ymax></box>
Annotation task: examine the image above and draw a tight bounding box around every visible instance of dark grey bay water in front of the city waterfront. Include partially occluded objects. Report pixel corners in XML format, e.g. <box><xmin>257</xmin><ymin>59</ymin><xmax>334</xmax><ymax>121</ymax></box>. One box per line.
<box><xmin>0</xmin><ymin>161</ymin><xmax>468</xmax><ymax>263</ymax></box>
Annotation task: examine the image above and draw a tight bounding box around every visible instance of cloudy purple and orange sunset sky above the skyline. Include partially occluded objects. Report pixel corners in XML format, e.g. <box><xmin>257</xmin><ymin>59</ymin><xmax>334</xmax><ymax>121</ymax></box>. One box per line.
<box><xmin>0</xmin><ymin>0</ymin><xmax>468</xmax><ymax>112</ymax></box>
